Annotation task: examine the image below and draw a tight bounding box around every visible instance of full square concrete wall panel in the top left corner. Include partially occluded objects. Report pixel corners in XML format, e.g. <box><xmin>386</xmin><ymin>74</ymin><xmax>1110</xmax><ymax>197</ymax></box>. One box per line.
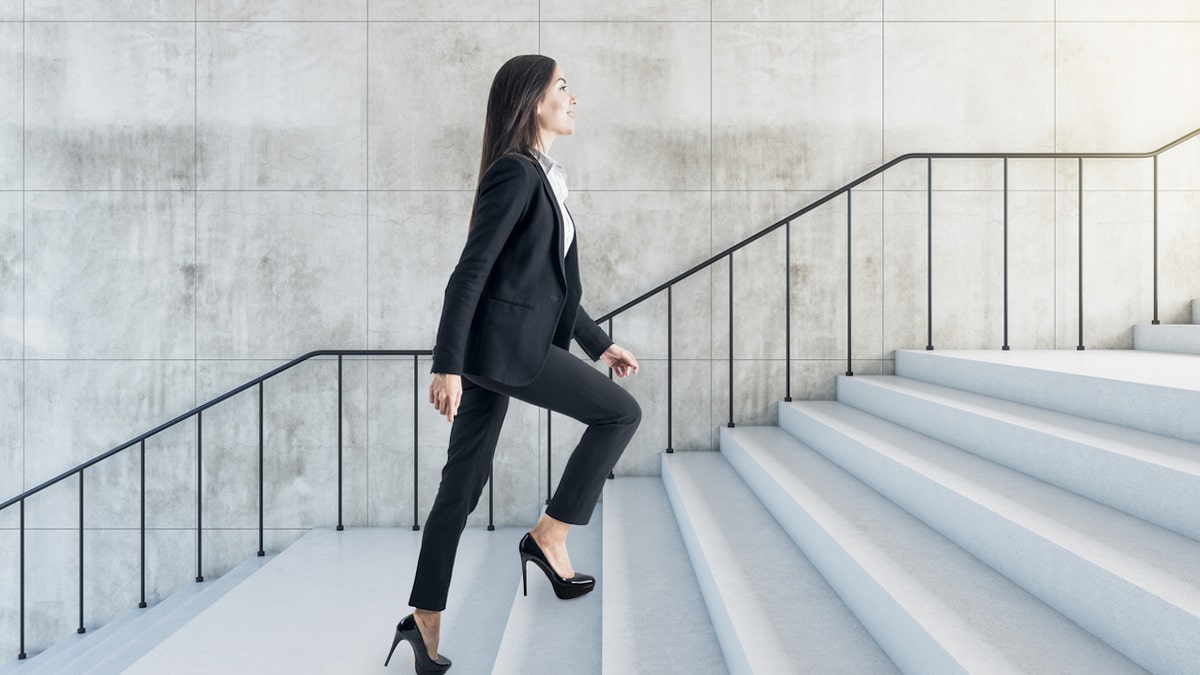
<box><xmin>25</xmin><ymin>22</ymin><xmax>196</xmax><ymax>190</ymax></box>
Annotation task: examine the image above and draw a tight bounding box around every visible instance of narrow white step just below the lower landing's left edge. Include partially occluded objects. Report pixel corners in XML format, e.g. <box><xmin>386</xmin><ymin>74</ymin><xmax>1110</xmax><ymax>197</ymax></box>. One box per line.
<box><xmin>73</xmin><ymin>555</ymin><xmax>276</xmax><ymax>675</ymax></box>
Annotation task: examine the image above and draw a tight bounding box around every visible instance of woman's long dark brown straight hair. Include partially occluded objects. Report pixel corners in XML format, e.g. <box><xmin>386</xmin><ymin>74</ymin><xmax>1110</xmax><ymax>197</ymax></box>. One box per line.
<box><xmin>470</xmin><ymin>54</ymin><xmax>558</xmax><ymax>227</ymax></box>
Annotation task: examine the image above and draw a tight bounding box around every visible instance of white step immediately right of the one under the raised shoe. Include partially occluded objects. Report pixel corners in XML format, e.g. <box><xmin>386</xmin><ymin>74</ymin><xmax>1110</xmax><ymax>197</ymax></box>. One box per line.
<box><xmin>602</xmin><ymin>477</ymin><xmax>728</xmax><ymax>675</ymax></box>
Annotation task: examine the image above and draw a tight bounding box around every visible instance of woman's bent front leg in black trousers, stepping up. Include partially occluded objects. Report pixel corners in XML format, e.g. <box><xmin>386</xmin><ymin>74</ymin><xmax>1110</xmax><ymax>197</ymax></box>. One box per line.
<box><xmin>465</xmin><ymin>346</ymin><xmax>642</xmax><ymax>577</ymax></box>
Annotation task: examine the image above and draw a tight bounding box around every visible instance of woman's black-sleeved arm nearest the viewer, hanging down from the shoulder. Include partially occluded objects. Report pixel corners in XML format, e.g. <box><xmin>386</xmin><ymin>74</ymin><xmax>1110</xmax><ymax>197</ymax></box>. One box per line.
<box><xmin>433</xmin><ymin>156</ymin><xmax>536</xmax><ymax>375</ymax></box>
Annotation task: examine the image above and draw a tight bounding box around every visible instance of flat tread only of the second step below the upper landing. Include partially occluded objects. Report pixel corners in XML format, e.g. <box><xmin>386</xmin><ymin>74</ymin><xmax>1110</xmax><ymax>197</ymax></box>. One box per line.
<box><xmin>790</xmin><ymin>401</ymin><xmax>1200</xmax><ymax>605</ymax></box>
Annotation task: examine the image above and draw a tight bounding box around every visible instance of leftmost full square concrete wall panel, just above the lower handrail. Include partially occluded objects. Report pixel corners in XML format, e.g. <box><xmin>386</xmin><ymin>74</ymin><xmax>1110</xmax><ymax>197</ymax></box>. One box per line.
<box><xmin>24</xmin><ymin>191</ymin><xmax>197</xmax><ymax>359</ymax></box>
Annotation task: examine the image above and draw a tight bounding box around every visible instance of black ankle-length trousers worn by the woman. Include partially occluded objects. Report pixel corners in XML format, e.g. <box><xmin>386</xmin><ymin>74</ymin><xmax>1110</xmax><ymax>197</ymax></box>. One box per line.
<box><xmin>408</xmin><ymin>346</ymin><xmax>642</xmax><ymax>611</ymax></box>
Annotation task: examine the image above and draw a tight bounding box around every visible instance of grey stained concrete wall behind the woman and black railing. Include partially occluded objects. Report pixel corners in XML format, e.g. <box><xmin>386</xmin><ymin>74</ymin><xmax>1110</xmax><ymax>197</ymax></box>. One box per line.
<box><xmin>0</xmin><ymin>0</ymin><xmax>1200</xmax><ymax>657</ymax></box>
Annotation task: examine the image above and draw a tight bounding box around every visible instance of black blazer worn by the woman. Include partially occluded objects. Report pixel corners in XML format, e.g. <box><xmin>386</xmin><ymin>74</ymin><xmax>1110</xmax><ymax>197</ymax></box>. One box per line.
<box><xmin>432</xmin><ymin>155</ymin><xmax>612</xmax><ymax>387</ymax></box>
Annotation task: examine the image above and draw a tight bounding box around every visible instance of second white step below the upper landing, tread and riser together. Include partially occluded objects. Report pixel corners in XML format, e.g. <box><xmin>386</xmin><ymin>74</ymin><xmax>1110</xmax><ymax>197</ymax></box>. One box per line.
<box><xmin>780</xmin><ymin>401</ymin><xmax>1200</xmax><ymax>674</ymax></box>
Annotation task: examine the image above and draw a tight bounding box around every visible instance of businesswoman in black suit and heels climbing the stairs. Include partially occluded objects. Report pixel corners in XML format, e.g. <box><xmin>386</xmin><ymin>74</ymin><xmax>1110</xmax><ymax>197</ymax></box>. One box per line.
<box><xmin>388</xmin><ymin>55</ymin><xmax>642</xmax><ymax>674</ymax></box>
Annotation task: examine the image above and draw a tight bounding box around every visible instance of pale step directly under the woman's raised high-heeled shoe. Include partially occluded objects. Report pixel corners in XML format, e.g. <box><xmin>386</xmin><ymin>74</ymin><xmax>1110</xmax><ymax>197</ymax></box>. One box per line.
<box><xmin>489</xmin><ymin>503</ymin><xmax>607</xmax><ymax>675</ymax></box>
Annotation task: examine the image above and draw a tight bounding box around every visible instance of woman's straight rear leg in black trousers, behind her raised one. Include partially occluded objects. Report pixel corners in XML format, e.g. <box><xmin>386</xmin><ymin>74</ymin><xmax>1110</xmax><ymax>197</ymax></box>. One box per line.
<box><xmin>408</xmin><ymin>377</ymin><xmax>509</xmax><ymax>658</ymax></box>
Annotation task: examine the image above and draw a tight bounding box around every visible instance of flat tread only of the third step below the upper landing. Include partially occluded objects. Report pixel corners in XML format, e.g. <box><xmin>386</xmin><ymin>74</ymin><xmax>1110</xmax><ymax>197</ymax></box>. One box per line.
<box><xmin>728</xmin><ymin>425</ymin><xmax>1141</xmax><ymax>673</ymax></box>
